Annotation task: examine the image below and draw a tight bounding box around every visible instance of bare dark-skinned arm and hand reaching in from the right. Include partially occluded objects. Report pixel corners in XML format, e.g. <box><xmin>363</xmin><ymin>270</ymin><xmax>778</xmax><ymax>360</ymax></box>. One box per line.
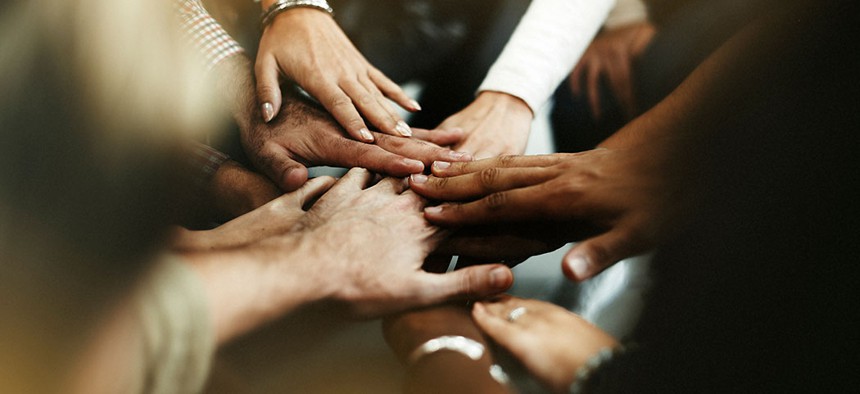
<box><xmin>412</xmin><ymin>12</ymin><xmax>783</xmax><ymax>280</ymax></box>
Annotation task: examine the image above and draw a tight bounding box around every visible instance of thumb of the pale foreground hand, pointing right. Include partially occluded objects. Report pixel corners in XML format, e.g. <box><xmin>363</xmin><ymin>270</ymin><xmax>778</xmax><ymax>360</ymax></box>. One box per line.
<box><xmin>422</xmin><ymin>264</ymin><xmax>514</xmax><ymax>305</ymax></box>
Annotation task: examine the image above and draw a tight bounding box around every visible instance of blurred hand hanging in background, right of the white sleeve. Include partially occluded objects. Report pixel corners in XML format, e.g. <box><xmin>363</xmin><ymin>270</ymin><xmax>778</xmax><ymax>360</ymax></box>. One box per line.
<box><xmin>570</xmin><ymin>22</ymin><xmax>656</xmax><ymax>119</ymax></box>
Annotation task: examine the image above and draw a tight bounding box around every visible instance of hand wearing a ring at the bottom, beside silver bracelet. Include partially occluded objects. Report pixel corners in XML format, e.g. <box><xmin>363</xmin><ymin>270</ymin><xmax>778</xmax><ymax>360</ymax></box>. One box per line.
<box><xmin>472</xmin><ymin>296</ymin><xmax>618</xmax><ymax>393</ymax></box>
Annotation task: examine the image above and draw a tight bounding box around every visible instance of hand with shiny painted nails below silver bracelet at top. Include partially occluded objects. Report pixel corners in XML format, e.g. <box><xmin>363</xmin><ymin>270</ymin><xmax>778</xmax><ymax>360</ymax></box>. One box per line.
<box><xmin>255</xmin><ymin>7</ymin><xmax>421</xmax><ymax>142</ymax></box>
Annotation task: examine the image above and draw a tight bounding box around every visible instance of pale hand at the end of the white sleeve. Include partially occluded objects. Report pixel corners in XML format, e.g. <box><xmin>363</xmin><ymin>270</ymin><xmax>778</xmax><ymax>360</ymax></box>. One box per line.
<box><xmin>437</xmin><ymin>92</ymin><xmax>534</xmax><ymax>159</ymax></box>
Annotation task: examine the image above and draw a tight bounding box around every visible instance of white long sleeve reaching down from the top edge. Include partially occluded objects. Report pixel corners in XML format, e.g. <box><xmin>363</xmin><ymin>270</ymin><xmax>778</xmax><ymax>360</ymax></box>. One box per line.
<box><xmin>478</xmin><ymin>0</ymin><xmax>615</xmax><ymax>113</ymax></box>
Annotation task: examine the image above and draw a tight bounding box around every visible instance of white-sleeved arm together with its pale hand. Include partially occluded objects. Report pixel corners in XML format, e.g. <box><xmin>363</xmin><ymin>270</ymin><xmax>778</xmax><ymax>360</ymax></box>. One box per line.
<box><xmin>438</xmin><ymin>0</ymin><xmax>612</xmax><ymax>159</ymax></box>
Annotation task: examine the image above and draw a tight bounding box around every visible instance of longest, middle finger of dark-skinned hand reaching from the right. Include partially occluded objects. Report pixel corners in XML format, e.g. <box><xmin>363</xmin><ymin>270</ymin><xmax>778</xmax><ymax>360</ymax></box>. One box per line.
<box><xmin>409</xmin><ymin>167</ymin><xmax>554</xmax><ymax>201</ymax></box>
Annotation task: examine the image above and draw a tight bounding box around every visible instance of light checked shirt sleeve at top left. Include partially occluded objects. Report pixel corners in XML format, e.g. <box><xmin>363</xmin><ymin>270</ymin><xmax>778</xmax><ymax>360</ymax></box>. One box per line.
<box><xmin>175</xmin><ymin>0</ymin><xmax>244</xmax><ymax>70</ymax></box>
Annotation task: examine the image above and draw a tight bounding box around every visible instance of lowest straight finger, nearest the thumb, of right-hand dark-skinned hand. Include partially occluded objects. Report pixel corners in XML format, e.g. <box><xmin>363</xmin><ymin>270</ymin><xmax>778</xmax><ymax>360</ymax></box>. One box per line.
<box><xmin>424</xmin><ymin>186</ymin><xmax>553</xmax><ymax>226</ymax></box>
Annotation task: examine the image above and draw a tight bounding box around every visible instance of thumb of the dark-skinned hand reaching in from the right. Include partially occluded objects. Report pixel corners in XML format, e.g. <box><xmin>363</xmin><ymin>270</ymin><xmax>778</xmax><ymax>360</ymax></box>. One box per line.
<box><xmin>562</xmin><ymin>231</ymin><xmax>634</xmax><ymax>281</ymax></box>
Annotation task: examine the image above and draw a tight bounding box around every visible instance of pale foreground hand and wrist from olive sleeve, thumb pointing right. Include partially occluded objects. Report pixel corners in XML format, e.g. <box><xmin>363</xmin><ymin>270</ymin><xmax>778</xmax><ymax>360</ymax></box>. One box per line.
<box><xmin>183</xmin><ymin>169</ymin><xmax>513</xmax><ymax>342</ymax></box>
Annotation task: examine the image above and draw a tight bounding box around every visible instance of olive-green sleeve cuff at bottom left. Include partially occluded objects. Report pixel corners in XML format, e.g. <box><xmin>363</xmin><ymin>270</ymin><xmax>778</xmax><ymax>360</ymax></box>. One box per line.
<box><xmin>129</xmin><ymin>256</ymin><xmax>215</xmax><ymax>394</ymax></box>
